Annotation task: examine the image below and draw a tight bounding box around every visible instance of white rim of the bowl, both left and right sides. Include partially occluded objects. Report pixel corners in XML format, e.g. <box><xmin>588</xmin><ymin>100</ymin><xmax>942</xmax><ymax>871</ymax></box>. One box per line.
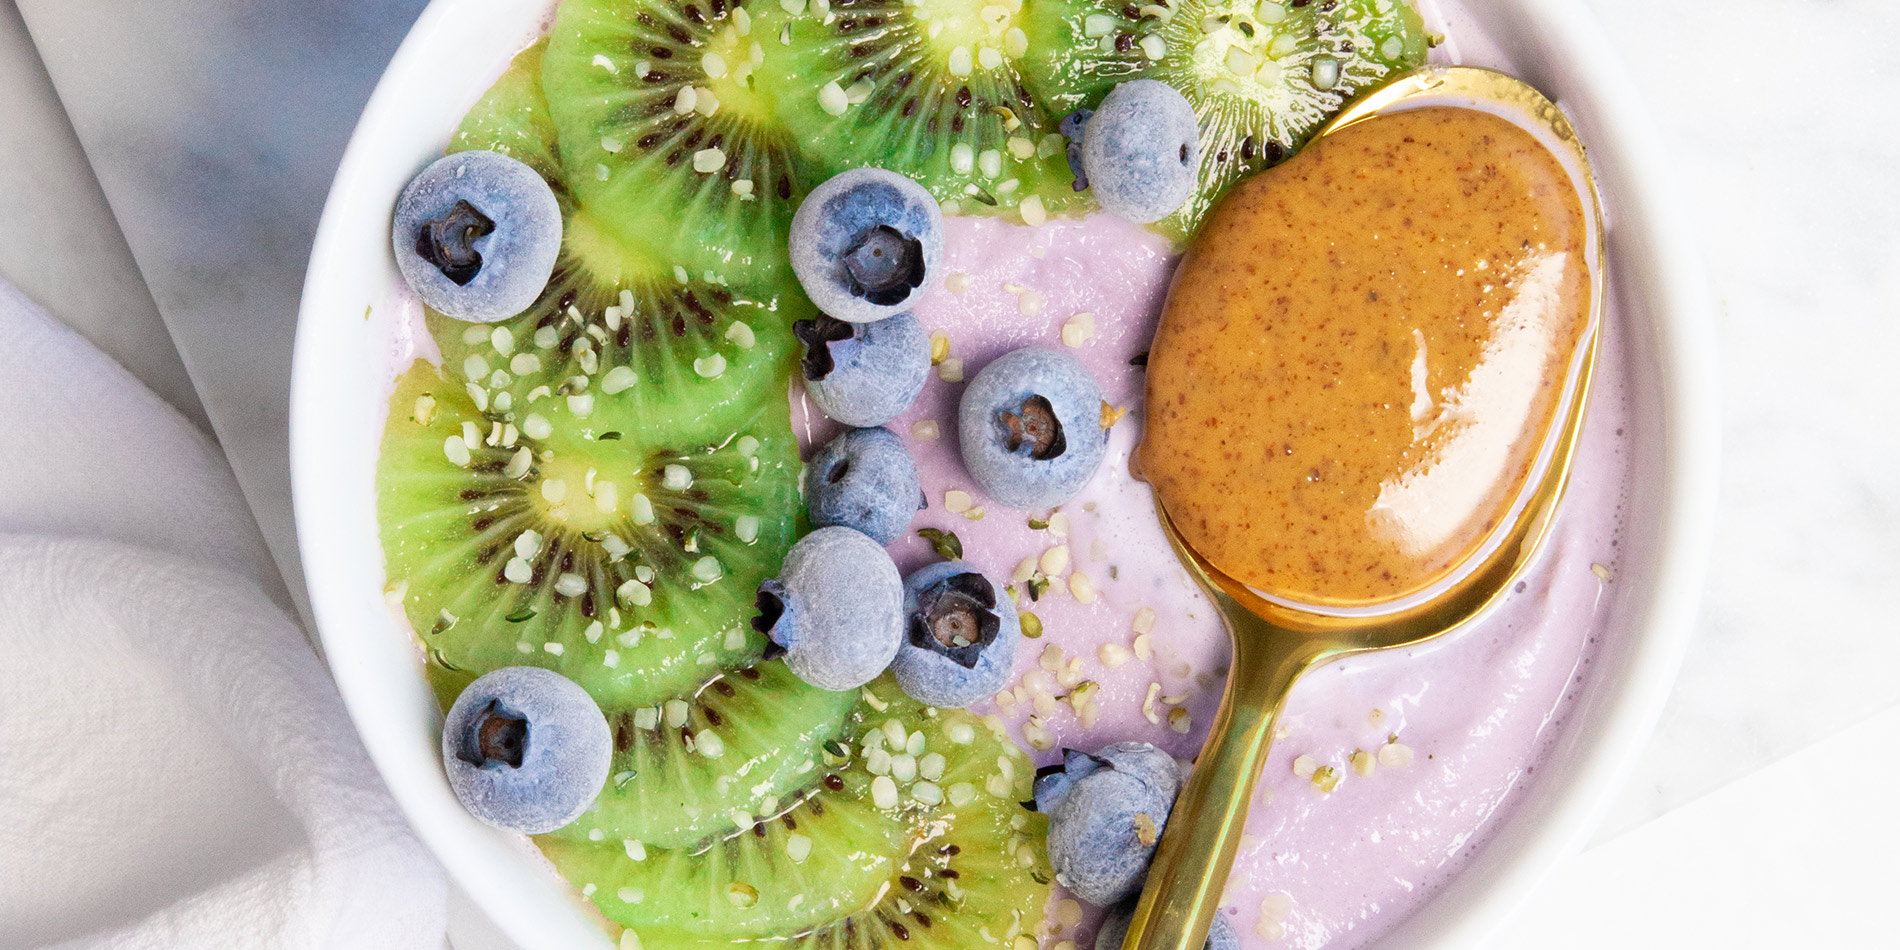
<box><xmin>289</xmin><ymin>0</ymin><xmax>1720</xmax><ymax>948</ymax></box>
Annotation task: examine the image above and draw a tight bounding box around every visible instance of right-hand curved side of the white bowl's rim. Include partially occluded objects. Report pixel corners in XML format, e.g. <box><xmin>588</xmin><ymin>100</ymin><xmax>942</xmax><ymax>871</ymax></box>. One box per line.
<box><xmin>1375</xmin><ymin>0</ymin><xmax>1721</xmax><ymax>946</ymax></box>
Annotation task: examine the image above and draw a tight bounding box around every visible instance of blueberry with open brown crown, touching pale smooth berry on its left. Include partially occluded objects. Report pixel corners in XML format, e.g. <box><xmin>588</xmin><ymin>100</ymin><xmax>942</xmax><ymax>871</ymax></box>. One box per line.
<box><xmin>891</xmin><ymin>561</ymin><xmax>1022</xmax><ymax>709</ymax></box>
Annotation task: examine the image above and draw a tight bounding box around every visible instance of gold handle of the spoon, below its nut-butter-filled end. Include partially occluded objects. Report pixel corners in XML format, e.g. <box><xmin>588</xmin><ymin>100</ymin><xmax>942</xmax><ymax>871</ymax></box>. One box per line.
<box><xmin>1121</xmin><ymin>615</ymin><xmax>1315</xmax><ymax>950</ymax></box>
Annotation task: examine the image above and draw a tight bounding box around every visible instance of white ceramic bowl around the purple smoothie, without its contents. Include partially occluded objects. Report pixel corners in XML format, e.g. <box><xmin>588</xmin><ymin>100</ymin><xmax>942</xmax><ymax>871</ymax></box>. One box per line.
<box><xmin>291</xmin><ymin>0</ymin><xmax>1718</xmax><ymax>948</ymax></box>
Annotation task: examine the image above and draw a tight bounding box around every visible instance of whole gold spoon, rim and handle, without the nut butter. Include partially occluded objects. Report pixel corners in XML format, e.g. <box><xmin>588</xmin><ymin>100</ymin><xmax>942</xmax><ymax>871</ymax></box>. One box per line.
<box><xmin>1123</xmin><ymin>67</ymin><xmax>1604</xmax><ymax>950</ymax></box>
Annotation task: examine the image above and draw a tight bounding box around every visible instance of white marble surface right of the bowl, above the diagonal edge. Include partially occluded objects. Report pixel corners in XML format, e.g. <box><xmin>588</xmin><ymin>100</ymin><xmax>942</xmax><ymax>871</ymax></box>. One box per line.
<box><xmin>1588</xmin><ymin>0</ymin><xmax>1900</xmax><ymax>834</ymax></box>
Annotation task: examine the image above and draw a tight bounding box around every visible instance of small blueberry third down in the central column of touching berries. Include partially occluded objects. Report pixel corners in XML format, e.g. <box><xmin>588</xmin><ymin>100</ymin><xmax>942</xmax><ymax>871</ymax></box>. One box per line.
<box><xmin>806</xmin><ymin>428</ymin><xmax>923</xmax><ymax>543</ymax></box>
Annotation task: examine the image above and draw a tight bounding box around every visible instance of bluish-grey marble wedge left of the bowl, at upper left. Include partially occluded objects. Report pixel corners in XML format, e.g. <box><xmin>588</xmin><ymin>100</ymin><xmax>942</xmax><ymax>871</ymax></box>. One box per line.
<box><xmin>17</xmin><ymin>0</ymin><xmax>424</xmax><ymax>623</ymax></box>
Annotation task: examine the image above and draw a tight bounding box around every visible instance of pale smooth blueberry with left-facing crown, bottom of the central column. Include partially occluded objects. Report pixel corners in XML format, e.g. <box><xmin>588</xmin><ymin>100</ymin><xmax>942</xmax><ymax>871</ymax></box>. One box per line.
<box><xmin>752</xmin><ymin>526</ymin><xmax>904</xmax><ymax>692</ymax></box>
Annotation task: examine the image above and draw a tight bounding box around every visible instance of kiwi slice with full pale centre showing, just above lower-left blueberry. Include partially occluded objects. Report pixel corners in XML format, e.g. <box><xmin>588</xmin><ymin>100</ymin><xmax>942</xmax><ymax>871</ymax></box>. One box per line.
<box><xmin>378</xmin><ymin>361</ymin><xmax>798</xmax><ymax>709</ymax></box>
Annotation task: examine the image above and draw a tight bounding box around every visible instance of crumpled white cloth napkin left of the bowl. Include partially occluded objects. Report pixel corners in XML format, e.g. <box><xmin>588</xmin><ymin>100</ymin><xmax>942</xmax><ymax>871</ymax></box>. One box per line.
<box><xmin>0</xmin><ymin>281</ymin><xmax>445</xmax><ymax>950</ymax></box>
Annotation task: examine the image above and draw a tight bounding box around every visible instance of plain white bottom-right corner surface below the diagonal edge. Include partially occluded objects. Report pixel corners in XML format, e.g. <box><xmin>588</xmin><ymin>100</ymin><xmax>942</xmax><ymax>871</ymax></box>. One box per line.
<box><xmin>1492</xmin><ymin>707</ymin><xmax>1900</xmax><ymax>950</ymax></box>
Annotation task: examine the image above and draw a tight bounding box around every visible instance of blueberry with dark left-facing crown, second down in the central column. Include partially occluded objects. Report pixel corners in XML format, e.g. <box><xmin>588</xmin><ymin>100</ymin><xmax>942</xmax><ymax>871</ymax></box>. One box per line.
<box><xmin>792</xmin><ymin>314</ymin><xmax>931</xmax><ymax>426</ymax></box>
